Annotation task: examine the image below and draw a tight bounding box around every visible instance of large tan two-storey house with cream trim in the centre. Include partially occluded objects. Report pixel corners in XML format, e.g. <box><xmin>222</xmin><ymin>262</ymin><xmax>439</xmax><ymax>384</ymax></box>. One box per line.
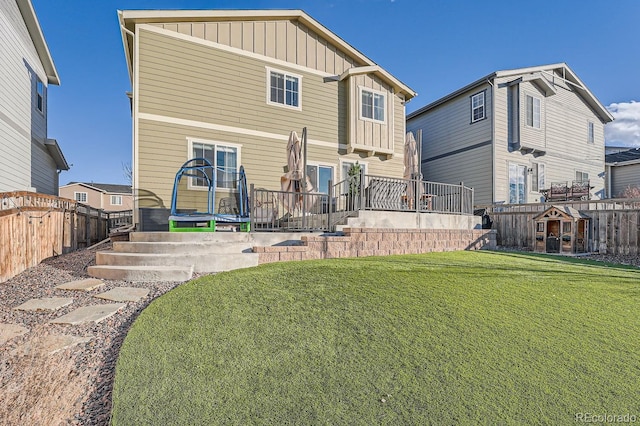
<box><xmin>119</xmin><ymin>10</ymin><xmax>416</xmax><ymax>229</ymax></box>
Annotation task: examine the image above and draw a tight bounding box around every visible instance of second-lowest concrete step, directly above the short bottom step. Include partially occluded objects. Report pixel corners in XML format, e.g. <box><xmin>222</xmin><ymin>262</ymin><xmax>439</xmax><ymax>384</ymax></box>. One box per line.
<box><xmin>96</xmin><ymin>251</ymin><xmax>258</xmax><ymax>273</ymax></box>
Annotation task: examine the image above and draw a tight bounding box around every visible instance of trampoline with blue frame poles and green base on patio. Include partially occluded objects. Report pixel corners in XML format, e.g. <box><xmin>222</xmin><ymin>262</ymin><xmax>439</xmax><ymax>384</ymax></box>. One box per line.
<box><xmin>169</xmin><ymin>158</ymin><xmax>251</xmax><ymax>232</ymax></box>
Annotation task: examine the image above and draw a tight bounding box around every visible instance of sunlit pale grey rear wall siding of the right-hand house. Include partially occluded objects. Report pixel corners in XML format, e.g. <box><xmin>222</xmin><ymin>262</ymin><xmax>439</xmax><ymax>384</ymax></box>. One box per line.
<box><xmin>494</xmin><ymin>75</ymin><xmax>604</xmax><ymax>202</ymax></box>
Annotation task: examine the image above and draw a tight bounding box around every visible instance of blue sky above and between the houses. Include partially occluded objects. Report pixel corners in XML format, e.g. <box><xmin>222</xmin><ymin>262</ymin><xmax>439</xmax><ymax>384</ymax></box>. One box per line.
<box><xmin>32</xmin><ymin>0</ymin><xmax>640</xmax><ymax>184</ymax></box>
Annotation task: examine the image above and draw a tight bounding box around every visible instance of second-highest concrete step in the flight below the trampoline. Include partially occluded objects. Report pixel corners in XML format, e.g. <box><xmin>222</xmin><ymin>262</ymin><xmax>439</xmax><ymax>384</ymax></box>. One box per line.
<box><xmin>113</xmin><ymin>241</ymin><xmax>254</xmax><ymax>254</ymax></box>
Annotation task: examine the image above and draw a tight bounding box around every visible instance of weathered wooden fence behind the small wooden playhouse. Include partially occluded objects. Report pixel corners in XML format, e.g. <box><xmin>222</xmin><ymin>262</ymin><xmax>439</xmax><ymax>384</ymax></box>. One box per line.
<box><xmin>476</xmin><ymin>198</ymin><xmax>640</xmax><ymax>255</ymax></box>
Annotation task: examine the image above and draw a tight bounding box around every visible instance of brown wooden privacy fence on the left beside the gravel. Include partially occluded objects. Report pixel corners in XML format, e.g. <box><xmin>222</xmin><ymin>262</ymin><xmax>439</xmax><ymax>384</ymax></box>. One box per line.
<box><xmin>0</xmin><ymin>192</ymin><xmax>129</xmax><ymax>282</ymax></box>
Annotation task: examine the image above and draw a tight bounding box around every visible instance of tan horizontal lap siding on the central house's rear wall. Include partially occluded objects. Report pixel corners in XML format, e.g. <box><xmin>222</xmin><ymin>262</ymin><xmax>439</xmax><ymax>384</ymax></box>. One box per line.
<box><xmin>135</xmin><ymin>26</ymin><xmax>404</xmax><ymax>208</ymax></box>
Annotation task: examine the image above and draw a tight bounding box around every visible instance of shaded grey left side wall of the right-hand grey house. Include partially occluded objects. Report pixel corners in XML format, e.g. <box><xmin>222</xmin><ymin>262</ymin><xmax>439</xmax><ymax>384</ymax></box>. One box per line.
<box><xmin>407</xmin><ymin>84</ymin><xmax>493</xmax><ymax>203</ymax></box>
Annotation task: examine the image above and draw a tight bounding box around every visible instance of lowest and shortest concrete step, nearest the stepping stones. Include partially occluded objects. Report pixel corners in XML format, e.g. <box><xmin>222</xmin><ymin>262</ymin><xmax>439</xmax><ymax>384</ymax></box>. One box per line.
<box><xmin>87</xmin><ymin>265</ymin><xmax>193</xmax><ymax>281</ymax></box>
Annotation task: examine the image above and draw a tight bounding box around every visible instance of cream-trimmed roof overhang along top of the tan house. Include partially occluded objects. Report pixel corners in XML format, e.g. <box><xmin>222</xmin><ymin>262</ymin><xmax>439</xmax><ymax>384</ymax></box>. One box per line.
<box><xmin>118</xmin><ymin>9</ymin><xmax>417</xmax><ymax>100</ymax></box>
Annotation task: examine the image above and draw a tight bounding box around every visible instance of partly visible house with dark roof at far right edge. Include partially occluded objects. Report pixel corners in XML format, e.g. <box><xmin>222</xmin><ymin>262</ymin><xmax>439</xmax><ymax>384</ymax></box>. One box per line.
<box><xmin>605</xmin><ymin>147</ymin><xmax>640</xmax><ymax>198</ymax></box>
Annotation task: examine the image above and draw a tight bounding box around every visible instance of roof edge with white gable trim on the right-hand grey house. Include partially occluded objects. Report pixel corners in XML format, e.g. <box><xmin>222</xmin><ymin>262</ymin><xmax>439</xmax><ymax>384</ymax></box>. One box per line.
<box><xmin>407</xmin><ymin>62</ymin><xmax>613</xmax><ymax>123</ymax></box>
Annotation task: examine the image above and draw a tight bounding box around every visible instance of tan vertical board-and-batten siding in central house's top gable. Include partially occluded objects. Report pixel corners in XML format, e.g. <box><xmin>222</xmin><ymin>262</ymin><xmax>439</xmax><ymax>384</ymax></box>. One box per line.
<box><xmin>151</xmin><ymin>20</ymin><xmax>364</xmax><ymax>75</ymax></box>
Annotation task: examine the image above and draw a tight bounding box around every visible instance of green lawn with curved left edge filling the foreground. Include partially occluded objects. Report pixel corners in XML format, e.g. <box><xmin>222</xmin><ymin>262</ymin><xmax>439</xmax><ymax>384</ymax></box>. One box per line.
<box><xmin>113</xmin><ymin>252</ymin><xmax>640</xmax><ymax>425</ymax></box>
